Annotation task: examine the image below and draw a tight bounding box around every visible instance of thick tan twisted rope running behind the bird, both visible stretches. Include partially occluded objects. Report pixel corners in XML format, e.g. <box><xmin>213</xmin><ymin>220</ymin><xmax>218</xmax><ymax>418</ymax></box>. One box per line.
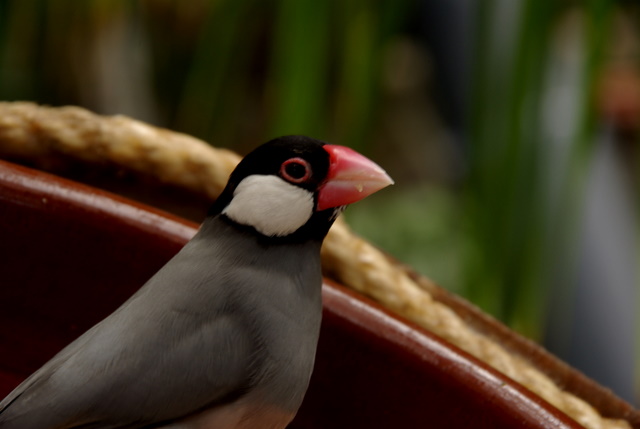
<box><xmin>0</xmin><ymin>103</ymin><xmax>630</xmax><ymax>429</ymax></box>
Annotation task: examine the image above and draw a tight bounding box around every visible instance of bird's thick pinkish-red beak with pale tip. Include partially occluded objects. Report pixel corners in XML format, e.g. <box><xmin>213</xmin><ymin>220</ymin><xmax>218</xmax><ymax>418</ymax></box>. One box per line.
<box><xmin>316</xmin><ymin>144</ymin><xmax>393</xmax><ymax>211</ymax></box>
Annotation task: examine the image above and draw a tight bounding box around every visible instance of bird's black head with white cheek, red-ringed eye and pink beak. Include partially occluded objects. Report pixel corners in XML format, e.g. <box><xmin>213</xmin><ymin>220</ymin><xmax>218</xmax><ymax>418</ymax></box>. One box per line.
<box><xmin>209</xmin><ymin>136</ymin><xmax>393</xmax><ymax>241</ymax></box>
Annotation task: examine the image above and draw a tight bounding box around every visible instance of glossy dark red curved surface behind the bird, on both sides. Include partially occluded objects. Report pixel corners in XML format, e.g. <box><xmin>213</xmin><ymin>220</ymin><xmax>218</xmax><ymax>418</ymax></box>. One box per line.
<box><xmin>0</xmin><ymin>162</ymin><xmax>580</xmax><ymax>429</ymax></box>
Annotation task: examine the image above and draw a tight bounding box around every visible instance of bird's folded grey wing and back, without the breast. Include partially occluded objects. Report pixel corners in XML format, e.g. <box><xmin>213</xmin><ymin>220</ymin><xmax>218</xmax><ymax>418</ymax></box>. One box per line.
<box><xmin>0</xmin><ymin>232</ymin><xmax>260</xmax><ymax>429</ymax></box>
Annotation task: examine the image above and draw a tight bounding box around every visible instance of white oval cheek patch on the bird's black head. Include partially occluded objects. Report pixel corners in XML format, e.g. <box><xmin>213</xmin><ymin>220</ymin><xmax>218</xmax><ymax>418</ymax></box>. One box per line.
<box><xmin>222</xmin><ymin>175</ymin><xmax>314</xmax><ymax>237</ymax></box>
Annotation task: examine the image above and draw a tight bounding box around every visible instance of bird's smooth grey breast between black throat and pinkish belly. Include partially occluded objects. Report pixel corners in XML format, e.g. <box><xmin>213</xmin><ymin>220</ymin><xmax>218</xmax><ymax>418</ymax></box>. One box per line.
<box><xmin>189</xmin><ymin>217</ymin><xmax>322</xmax><ymax>412</ymax></box>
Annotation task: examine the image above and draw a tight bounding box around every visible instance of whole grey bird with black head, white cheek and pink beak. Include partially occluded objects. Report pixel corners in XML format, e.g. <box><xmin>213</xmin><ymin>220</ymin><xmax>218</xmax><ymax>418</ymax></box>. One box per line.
<box><xmin>0</xmin><ymin>135</ymin><xmax>393</xmax><ymax>429</ymax></box>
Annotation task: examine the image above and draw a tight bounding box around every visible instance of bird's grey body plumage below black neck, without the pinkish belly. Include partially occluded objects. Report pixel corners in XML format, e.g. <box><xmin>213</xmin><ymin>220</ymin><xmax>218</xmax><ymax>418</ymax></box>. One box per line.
<box><xmin>0</xmin><ymin>218</ymin><xmax>321</xmax><ymax>429</ymax></box>
